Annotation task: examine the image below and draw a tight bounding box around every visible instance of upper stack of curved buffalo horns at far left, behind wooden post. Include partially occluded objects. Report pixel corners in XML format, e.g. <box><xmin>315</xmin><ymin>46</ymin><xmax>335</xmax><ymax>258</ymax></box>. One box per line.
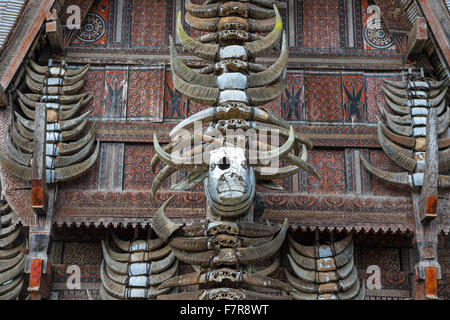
<box><xmin>0</xmin><ymin>59</ymin><xmax>99</xmax><ymax>183</ymax></box>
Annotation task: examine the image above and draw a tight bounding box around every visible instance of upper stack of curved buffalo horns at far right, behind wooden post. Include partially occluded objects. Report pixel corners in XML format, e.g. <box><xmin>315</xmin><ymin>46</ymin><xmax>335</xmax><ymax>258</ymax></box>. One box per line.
<box><xmin>361</xmin><ymin>73</ymin><xmax>450</xmax><ymax>188</ymax></box>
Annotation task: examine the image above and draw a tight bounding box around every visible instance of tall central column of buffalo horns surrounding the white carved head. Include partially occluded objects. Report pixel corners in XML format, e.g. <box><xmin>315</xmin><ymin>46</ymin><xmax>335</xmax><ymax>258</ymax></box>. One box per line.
<box><xmin>146</xmin><ymin>0</ymin><xmax>317</xmax><ymax>300</ymax></box>
